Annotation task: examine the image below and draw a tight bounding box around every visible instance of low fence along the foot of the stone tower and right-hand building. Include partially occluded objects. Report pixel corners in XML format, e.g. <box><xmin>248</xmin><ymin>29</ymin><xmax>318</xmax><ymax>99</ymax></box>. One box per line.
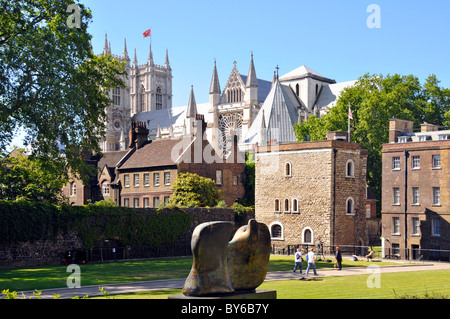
<box><xmin>271</xmin><ymin>244</ymin><xmax>450</xmax><ymax>261</ymax></box>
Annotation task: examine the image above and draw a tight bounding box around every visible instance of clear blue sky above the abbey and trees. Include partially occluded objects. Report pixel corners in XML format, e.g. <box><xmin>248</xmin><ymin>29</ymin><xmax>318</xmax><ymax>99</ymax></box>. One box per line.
<box><xmin>81</xmin><ymin>0</ymin><xmax>450</xmax><ymax>107</ymax></box>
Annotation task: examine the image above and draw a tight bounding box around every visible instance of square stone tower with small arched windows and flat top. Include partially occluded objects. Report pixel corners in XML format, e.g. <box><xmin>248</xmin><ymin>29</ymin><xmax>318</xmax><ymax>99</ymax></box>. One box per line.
<box><xmin>255</xmin><ymin>132</ymin><xmax>368</xmax><ymax>255</ymax></box>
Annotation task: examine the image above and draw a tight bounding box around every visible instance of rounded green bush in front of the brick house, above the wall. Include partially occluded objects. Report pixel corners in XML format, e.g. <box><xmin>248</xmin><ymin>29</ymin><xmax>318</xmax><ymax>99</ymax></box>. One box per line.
<box><xmin>169</xmin><ymin>173</ymin><xmax>220</xmax><ymax>207</ymax></box>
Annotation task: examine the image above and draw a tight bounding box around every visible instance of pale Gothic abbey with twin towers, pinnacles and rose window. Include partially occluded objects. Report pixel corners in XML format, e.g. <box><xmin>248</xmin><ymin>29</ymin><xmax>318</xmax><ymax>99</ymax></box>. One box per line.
<box><xmin>101</xmin><ymin>35</ymin><xmax>355</xmax><ymax>152</ymax></box>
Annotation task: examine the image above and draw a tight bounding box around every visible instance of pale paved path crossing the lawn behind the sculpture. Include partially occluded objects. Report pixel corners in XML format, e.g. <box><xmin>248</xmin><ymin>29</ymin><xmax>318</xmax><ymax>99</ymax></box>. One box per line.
<box><xmin>18</xmin><ymin>262</ymin><xmax>450</xmax><ymax>299</ymax></box>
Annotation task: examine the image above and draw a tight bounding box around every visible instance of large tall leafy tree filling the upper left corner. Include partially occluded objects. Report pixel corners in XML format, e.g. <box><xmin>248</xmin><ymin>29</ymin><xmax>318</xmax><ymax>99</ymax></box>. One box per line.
<box><xmin>0</xmin><ymin>0</ymin><xmax>125</xmax><ymax>184</ymax></box>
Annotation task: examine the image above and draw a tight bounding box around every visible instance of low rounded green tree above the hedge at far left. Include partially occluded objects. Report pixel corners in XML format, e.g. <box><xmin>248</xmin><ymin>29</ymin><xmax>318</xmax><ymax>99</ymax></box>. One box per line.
<box><xmin>0</xmin><ymin>149</ymin><xmax>67</xmax><ymax>204</ymax></box>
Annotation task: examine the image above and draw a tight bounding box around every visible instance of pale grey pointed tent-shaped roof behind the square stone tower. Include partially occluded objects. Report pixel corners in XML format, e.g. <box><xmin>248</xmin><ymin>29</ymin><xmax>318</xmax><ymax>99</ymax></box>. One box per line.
<box><xmin>244</xmin><ymin>79</ymin><xmax>300</xmax><ymax>143</ymax></box>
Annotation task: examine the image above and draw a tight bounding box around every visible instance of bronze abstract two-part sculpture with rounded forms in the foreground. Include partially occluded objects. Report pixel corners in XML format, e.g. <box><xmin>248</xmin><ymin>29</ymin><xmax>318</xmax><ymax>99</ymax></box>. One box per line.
<box><xmin>183</xmin><ymin>219</ymin><xmax>270</xmax><ymax>297</ymax></box>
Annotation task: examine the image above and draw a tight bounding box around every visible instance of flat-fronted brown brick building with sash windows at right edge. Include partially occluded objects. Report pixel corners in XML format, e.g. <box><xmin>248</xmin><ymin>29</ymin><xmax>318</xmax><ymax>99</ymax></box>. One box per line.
<box><xmin>382</xmin><ymin>119</ymin><xmax>450</xmax><ymax>260</ymax></box>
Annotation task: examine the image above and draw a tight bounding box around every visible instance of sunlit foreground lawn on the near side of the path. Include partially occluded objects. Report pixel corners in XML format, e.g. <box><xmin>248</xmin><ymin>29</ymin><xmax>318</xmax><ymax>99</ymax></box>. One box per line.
<box><xmin>93</xmin><ymin>270</ymin><xmax>450</xmax><ymax>299</ymax></box>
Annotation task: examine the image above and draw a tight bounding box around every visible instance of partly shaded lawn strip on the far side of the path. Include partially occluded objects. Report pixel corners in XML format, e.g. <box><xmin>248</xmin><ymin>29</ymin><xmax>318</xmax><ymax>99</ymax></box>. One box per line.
<box><xmin>0</xmin><ymin>255</ymin><xmax>414</xmax><ymax>291</ymax></box>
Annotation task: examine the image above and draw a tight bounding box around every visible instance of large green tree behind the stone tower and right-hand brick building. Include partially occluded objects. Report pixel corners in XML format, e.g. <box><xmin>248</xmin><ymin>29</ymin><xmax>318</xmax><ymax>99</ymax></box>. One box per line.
<box><xmin>295</xmin><ymin>74</ymin><xmax>450</xmax><ymax>212</ymax></box>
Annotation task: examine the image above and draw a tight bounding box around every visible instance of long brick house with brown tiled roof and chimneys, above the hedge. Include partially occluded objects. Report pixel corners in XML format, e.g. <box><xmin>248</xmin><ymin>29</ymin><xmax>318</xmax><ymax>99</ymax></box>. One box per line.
<box><xmin>63</xmin><ymin>87</ymin><xmax>245</xmax><ymax>208</ymax></box>
